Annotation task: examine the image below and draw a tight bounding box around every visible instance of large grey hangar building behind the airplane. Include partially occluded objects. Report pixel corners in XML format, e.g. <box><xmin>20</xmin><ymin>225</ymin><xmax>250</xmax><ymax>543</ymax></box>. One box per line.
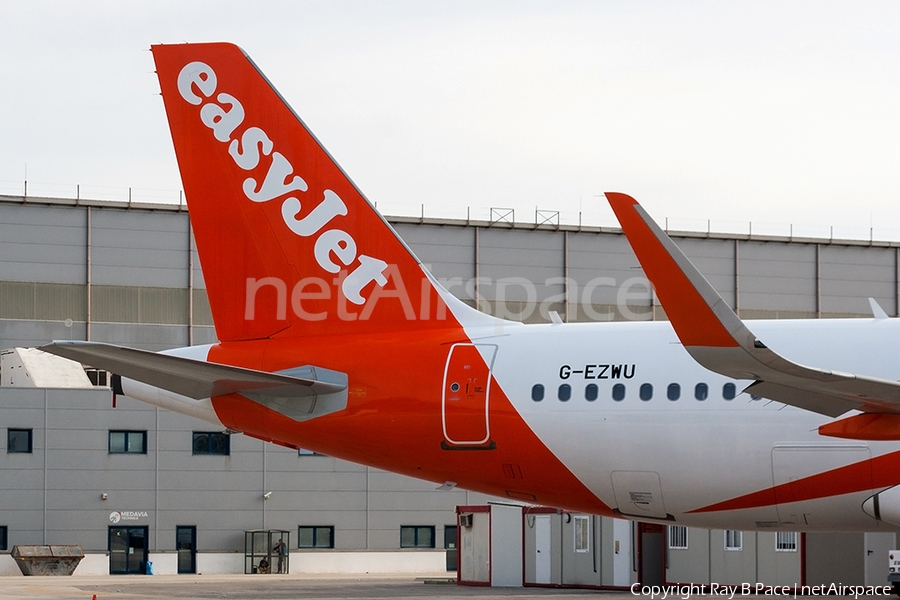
<box><xmin>0</xmin><ymin>191</ymin><xmax>900</xmax><ymax>585</ymax></box>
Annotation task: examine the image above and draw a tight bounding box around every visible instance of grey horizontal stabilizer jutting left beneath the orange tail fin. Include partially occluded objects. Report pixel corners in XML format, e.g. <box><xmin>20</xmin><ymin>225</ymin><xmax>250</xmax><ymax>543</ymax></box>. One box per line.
<box><xmin>40</xmin><ymin>341</ymin><xmax>347</xmax><ymax>400</ymax></box>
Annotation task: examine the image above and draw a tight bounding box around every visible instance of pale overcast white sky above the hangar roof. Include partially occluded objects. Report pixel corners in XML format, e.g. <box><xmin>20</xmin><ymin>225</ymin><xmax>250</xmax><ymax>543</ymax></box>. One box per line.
<box><xmin>0</xmin><ymin>0</ymin><xmax>900</xmax><ymax>237</ymax></box>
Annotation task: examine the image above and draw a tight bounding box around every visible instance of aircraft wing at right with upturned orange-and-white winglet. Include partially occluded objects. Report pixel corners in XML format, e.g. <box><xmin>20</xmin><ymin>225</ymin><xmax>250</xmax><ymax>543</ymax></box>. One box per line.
<box><xmin>606</xmin><ymin>193</ymin><xmax>900</xmax><ymax>417</ymax></box>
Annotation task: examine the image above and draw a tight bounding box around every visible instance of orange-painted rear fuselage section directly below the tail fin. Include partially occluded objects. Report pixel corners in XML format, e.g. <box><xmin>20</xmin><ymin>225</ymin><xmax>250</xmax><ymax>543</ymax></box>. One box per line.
<box><xmin>209</xmin><ymin>330</ymin><xmax>612</xmax><ymax>516</ymax></box>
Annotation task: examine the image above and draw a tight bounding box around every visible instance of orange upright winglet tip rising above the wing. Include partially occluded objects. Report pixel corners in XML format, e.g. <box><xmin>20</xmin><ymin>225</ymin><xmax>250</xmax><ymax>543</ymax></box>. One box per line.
<box><xmin>606</xmin><ymin>192</ymin><xmax>738</xmax><ymax>347</ymax></box>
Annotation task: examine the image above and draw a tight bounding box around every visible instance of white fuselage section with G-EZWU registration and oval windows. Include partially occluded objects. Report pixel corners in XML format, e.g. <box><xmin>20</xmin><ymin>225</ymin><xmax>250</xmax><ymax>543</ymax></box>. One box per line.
<box><xmin>467</xmin><ymin>319</ymin><xmax>900</xmax><ymax>530</ymax></box>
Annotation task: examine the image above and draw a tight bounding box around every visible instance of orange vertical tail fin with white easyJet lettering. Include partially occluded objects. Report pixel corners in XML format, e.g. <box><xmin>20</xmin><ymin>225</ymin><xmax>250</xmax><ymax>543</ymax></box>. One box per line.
<box><xmin>151</xmin><ymin>43</ymin><xmax>486</xmax><ymax>341</ymax></box>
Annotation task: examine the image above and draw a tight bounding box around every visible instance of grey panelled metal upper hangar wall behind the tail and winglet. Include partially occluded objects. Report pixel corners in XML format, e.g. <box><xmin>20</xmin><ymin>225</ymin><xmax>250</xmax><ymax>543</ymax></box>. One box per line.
<box><xmin>0</xmin><ymin>197</ymin><xmax>898</xmax><ymax>350</ymax></box>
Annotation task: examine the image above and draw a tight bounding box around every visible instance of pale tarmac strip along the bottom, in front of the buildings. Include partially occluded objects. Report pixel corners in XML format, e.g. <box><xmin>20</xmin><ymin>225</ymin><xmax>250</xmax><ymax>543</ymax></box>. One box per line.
<box><xmin>0</xmin><ymin>573</ymin><xmax>894</xmax><ymax>600</ymax></box>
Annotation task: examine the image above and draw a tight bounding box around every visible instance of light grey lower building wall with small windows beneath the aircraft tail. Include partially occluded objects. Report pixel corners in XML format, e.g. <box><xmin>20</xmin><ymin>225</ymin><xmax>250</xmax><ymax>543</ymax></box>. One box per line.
<box><xmin>0</xmin><ymin>388</ymin><xmax>486</xmax><ymax>570</ymax></box>
